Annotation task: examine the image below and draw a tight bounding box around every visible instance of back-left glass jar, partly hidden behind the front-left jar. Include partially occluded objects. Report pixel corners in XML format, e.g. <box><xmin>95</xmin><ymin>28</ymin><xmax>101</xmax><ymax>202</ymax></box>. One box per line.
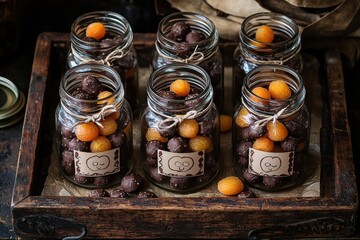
<box><xmin>68</xmin><ymin>11</ymin><xmax>139</xmax><ymax>112</ymax></box>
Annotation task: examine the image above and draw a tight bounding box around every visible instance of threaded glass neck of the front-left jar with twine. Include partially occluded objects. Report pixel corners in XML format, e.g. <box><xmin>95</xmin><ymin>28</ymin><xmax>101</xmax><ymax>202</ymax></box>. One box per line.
<box><xmin>59</xmin><ymin>64</ymin><xmax>124</xmax><ymax>125</ymax></box>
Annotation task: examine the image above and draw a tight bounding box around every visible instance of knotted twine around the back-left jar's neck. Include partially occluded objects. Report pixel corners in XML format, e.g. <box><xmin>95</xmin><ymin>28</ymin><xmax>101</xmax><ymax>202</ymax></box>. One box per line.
<box><xmin>71</xmin><ymin>44</ymin><xmax>131</xmax><ymax>66</ymax></box>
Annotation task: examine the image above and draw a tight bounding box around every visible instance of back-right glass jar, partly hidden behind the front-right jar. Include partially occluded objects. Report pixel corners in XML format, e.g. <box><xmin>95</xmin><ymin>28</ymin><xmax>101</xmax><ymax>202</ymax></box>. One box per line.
<box><xmin>233</xmin><ymin>12</ymin><xmax>302</xmax><ymax>105</ymax></box>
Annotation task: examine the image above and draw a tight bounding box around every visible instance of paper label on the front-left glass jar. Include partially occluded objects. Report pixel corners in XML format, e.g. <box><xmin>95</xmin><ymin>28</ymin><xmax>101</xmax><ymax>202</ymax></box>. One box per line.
<box><xmin>74</xmin><ymin>148</ymin><xmax>120</xmax><ymax>177</ymax></box>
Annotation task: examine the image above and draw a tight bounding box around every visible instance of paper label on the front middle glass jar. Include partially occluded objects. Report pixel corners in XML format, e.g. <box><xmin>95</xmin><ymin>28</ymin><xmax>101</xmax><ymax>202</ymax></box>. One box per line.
<box><xmin>157</xmin><ymin>150</ymin><xmax>205</xmax><ymax>177</ymax></box>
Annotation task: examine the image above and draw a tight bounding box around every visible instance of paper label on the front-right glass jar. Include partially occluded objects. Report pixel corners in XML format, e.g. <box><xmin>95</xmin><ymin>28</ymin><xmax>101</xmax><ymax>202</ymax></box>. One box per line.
<box><xmin>249</xmin><ymin>148</ymin><xmax>294</xmax><ymax>177</ymax></box>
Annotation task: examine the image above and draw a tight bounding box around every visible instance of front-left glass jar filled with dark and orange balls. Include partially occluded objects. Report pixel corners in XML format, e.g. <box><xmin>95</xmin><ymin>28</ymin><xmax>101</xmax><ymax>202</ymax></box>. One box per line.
<box><xmin>55</xmin><ymin>64</ymin><xmax>132</xmax><ymax>188</ymax></box>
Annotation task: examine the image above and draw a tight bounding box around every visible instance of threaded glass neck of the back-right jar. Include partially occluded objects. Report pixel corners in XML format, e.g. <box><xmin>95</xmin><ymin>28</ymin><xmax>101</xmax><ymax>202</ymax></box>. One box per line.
<box><xmin>239</xmin><ymin>12</ymin><xmax>301</xmax><ymax>65</ymax></box>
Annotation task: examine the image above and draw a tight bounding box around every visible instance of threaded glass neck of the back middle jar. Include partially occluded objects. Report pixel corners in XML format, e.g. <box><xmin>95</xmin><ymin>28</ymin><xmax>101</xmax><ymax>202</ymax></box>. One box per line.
<box><xmin>156</xmin><ymin>12</ymin><xmax>219</xmax><ymax>64</ymax></box>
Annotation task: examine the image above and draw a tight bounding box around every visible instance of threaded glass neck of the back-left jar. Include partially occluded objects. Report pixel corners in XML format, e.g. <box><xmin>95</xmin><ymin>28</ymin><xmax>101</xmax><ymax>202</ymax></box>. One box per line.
<box><xmin>71</xmin><ymin>11</ymin><xmax>133</xmax><ymax>65</ymax></box>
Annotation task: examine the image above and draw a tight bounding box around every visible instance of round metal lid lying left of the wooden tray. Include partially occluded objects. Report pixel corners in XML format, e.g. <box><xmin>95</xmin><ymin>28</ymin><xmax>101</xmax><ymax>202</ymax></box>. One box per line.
<box><xmin>0</xmin><ymin>76</ymin><xmax>25</xmax><ymax>128</ymax></box>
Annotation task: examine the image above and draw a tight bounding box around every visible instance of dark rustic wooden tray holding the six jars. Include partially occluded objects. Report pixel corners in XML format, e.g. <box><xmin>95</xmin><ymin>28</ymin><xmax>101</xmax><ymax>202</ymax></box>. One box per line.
<box><xmin>12</xmin><ymin>33</ymin><xmax>358</xmax><ymax>239</ymax></box>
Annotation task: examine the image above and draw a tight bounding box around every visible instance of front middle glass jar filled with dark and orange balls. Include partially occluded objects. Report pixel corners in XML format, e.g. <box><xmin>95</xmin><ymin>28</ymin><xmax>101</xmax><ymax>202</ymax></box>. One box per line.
<box><xmin>141</xmin><ymin>63</ymin><xmax>220</xmax><ymax>193</ymax></box>
